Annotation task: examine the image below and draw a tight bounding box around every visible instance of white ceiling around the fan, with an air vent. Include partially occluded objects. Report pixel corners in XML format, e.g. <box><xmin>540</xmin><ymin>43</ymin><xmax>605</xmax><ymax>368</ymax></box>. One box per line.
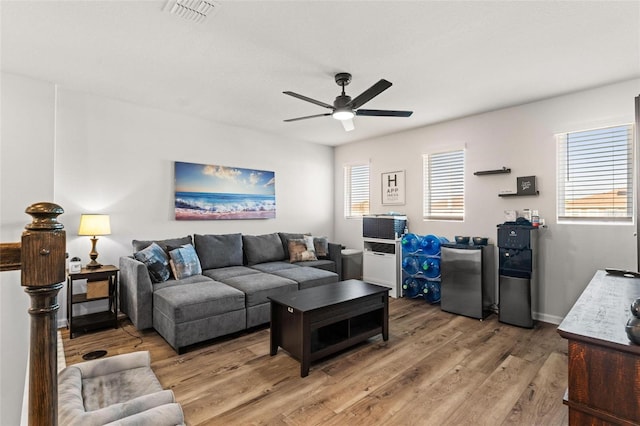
<box><xmin>0</xmin><ymin>0</ymin><xmax>640</xmax><ymax>145</ymax></box>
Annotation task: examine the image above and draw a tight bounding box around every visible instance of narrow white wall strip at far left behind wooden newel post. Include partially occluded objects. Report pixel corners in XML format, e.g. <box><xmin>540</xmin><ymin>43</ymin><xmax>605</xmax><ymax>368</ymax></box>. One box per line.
<box><xmin>0</xmin><ymin>73</ymin><xmax>56</xmax><ymax>425</ymax></box>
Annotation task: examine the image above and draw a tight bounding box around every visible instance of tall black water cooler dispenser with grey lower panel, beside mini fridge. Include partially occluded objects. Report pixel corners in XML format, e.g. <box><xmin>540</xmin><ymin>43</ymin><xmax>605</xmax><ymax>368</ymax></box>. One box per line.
<box><xmin>498</xmin><ymin>223</ymin><xmax>538</xmax><ymax>328</ymax></box>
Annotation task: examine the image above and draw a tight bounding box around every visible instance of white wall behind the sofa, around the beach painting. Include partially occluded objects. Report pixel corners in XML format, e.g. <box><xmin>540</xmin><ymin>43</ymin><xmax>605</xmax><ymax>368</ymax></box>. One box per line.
<box><xmin>54</xmin><ymin>89</ymin><xmax>333</xmax><ymax>318</ymax></box>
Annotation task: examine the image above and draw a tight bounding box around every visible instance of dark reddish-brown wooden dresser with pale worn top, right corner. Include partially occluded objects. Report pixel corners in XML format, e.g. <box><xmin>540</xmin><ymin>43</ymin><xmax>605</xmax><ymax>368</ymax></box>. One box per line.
<box><xmin>558</xmin><ymin>271</ymin><xmax>640</xmax><ymax>425</ymax></box>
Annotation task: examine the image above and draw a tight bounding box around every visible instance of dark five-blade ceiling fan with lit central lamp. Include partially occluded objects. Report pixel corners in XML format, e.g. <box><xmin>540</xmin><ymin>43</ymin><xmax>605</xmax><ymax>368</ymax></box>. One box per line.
<box><xmin>282</xmin><ymin>72</ymin><xmax>413</xmax><ymax>132</ymax></box>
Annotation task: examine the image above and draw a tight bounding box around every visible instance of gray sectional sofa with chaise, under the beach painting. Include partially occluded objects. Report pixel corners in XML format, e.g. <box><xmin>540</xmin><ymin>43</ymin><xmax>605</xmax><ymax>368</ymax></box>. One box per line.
<box><xmin>120</xmin><ymin>233</ymin><xmax>342</xmax><ymax>353</ymax></box>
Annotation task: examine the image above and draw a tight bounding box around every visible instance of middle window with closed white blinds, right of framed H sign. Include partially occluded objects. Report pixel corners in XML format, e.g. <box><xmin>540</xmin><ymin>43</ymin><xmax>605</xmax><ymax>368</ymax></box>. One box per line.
<box><xmin>422</xmin><ymin>150</ymin><xmax>464</xmax><ymax>220</ymax></box>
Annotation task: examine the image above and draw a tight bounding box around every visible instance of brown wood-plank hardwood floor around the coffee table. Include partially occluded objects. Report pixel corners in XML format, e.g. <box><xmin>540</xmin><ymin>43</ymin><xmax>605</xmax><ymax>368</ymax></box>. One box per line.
<box><xmin>62</xmin><ymin>299</ymin><xmax>568</xmax><ymax>426</ymax></box>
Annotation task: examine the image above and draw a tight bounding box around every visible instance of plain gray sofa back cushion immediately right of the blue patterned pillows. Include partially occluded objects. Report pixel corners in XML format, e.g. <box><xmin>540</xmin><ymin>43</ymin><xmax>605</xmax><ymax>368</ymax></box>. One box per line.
<box><xmin>193</xmin><ymin>234</ymin><xmax>242</xmax><ymax>270</ymax></box>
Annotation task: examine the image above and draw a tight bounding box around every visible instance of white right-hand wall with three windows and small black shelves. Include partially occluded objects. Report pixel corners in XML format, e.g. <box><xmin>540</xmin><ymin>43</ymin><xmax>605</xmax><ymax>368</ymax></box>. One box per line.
<box><xmin>334</xmin><ymin>80</ymin><xmax>640</xmax><ymax>322</ymax></box>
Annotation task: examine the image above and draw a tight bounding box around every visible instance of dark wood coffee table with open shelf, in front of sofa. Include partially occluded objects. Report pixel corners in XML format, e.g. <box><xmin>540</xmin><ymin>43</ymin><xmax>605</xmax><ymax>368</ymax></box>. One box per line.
<box><xmin>269</xmin><ymin>280</ymin><xmax>389</xmax><ymax>377</ymax></box>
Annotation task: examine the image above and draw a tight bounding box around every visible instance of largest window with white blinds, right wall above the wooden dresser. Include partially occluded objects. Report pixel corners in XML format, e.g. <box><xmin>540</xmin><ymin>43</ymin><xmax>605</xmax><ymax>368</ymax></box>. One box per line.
<box><xmin>556</xmin><ymin>124</ymin><xmax>634</xmax><ymax>222</ymax></box>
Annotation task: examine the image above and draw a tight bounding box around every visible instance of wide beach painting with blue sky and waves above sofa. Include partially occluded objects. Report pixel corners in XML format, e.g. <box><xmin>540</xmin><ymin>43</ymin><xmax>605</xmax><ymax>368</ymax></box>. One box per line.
<box><xmin>175</xmin><ymin>161</ymin><xmax>276</xmax><ymax>220</ymax></box>
